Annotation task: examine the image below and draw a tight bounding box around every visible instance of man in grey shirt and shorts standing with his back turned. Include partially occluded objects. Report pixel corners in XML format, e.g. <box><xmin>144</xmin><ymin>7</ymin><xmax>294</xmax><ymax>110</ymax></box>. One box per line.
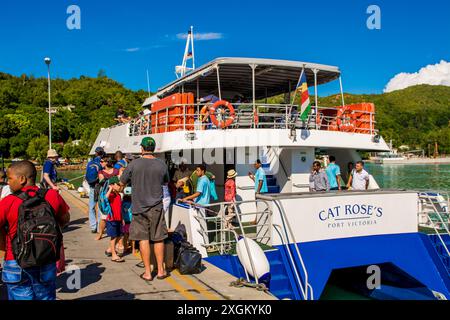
<box><xmin>120</xmin><ymin>137</ymin><xmax>169</xmax><ymax>281</ymax></box>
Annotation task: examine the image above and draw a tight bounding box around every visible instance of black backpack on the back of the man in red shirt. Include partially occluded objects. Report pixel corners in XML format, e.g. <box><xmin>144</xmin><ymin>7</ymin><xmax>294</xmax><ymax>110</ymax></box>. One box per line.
<box><xmin>11</xmin><ymin>189</ymin><xmax>63</xmax><ymax>268</ymax></box>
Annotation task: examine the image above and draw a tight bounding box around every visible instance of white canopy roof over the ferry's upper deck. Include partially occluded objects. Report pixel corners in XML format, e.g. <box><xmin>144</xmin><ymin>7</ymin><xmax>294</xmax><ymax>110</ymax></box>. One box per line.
<box><xmin>157</xmin><ymin>58</ymin><xmax>340</xmax><ymax>99</ymax></box>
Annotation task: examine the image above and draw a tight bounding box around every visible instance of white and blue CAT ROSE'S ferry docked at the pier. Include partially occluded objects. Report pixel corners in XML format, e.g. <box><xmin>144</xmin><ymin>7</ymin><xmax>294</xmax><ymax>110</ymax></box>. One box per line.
<box><xmin>91</xmin><ymin>30</ymin><xmax>450</xmax><ymax>300</ymax></box>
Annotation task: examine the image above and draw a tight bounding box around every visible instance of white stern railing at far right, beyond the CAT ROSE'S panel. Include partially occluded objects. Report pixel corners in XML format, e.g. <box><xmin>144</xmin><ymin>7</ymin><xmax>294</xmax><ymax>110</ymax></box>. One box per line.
<box><xmin>419</xmin><ymin>191</ymin><xmax>450</xmax><ymax>256</ymax></box>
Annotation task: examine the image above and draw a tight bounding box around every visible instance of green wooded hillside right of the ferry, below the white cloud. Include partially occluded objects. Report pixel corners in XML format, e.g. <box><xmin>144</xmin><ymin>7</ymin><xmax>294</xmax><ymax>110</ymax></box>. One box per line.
<box><xmin>319</xmin><ymin>85</ymin><xmax>450</xmax><ymax>154</ymax></box>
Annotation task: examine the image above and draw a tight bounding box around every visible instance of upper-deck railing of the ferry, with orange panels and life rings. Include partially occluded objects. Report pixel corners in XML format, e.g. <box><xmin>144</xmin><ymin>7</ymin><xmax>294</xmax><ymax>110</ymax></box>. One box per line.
<box><xmin>128</xmin><ymin>103</ymin><xmax>378</xmax><ymax>136</ymax></box>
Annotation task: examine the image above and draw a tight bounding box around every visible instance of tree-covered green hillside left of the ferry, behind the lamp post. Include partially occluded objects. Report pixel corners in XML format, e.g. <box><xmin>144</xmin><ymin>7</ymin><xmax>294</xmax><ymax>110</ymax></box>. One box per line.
<box><xmin>0</xmin><ymin>72</ymin><xmax>147</xmax><ymax>160</ymax></box>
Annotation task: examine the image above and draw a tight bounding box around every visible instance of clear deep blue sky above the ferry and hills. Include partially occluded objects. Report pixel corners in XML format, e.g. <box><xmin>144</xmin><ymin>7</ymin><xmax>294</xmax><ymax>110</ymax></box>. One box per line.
<box><xmin>0</xmin><ymin>0</ymin><xmax>450</xmax><ymax>94</ymax></box>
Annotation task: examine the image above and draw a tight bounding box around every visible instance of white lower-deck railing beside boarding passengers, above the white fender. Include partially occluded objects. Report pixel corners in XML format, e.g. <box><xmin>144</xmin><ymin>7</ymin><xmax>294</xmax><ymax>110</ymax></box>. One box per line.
<box><xmin>181</xmin><ymin>200</ymin><xmax>272</xmax><ymax>283</ymax></box>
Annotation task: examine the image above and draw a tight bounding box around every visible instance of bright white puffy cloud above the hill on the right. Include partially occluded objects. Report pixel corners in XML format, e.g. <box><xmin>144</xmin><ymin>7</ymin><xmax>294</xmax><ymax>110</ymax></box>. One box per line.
<box><xmin>384</xmin><ymin>60</ymin><xmax>450</xmax><ymax>92</ymax></box>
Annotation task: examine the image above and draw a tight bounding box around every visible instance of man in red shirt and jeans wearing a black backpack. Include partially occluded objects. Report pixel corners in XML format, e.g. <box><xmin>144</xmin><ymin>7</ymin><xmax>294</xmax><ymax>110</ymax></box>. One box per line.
<box><xmin>0</xmin><ymin>161</ymin><xmax>70</xmax><ymax>300</ymax></box>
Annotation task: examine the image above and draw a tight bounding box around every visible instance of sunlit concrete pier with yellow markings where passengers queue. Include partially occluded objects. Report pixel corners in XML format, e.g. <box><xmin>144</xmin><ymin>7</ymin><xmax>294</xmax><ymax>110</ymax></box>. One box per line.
<box><xmin>57</xmin><ymin>190</ymin><xmax>276</xmax><ymax>300</ymax></box>
